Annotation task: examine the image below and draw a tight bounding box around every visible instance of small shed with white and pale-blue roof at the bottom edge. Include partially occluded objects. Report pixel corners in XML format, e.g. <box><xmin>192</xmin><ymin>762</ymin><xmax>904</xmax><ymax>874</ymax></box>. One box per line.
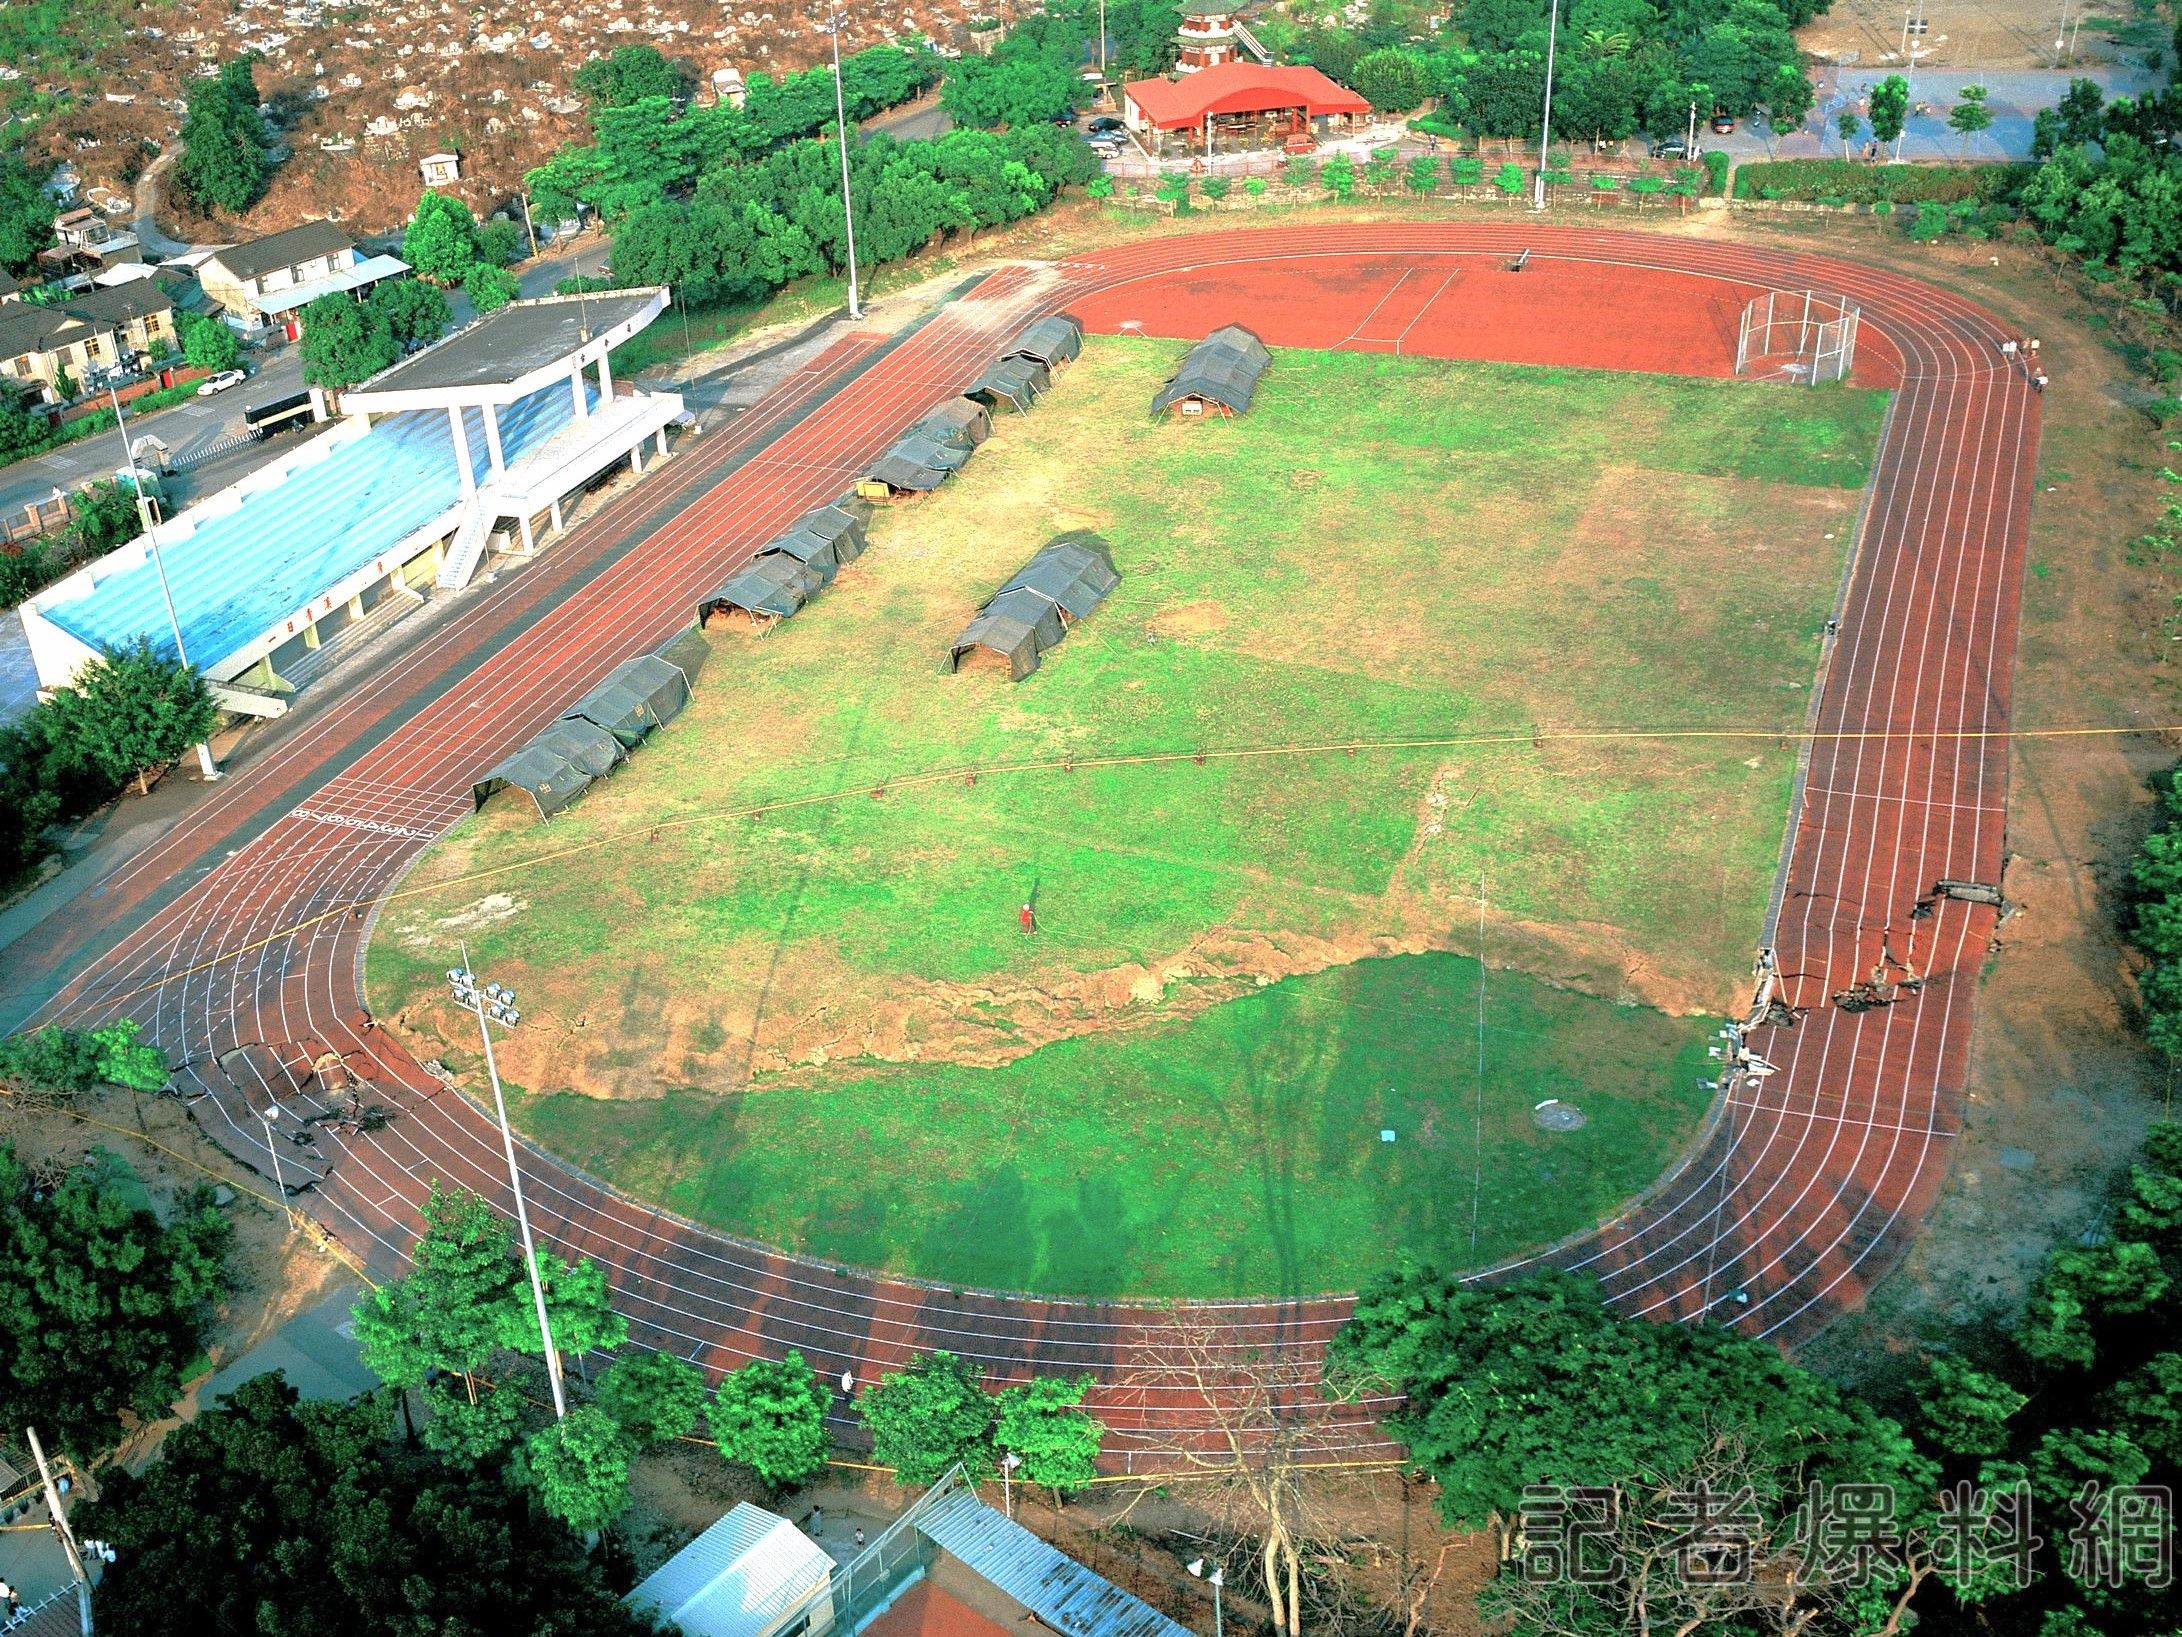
<box><xmin>624</xmin><ymin>1502</ymin><xmax>834</xmax><ymax>1637</ymax></box>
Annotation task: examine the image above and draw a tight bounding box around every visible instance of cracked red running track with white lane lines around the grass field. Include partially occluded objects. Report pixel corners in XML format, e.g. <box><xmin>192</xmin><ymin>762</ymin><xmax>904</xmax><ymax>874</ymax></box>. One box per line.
<box><xmin>9</xmin><ymin>225</ymin><xmax>2038</xmax><ymax>1454</ymax></box>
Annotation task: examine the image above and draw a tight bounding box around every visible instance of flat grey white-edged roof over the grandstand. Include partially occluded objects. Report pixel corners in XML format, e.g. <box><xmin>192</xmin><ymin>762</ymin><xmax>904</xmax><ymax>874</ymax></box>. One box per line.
<box><xmin>340</xmin><ymin>284</ymin><xmax>668</xmax><ymax>415</ymax></box>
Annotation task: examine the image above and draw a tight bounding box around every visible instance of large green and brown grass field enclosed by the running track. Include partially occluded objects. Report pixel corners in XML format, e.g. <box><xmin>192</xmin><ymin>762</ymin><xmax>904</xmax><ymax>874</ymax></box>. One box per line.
<box><xmin>369</xmin><ymin>340</ymin><xmax>1883</xmax><ymax>1294</ymax></box>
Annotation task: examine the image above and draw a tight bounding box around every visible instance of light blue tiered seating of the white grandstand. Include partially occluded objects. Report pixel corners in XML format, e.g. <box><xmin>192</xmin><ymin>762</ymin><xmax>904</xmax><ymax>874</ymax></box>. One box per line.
<box><xmin>41</xmin><ymin>382</ymin><xmax>598</xmax><ymax>668</ymax></box>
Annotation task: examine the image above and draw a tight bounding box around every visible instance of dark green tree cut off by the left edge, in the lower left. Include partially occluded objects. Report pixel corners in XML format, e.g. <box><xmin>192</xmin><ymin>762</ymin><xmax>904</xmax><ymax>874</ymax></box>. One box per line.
<box><xmin>0</xmin><ymin>1144</ymin><xmax>233</xmax><ymax>1462</ymax></box>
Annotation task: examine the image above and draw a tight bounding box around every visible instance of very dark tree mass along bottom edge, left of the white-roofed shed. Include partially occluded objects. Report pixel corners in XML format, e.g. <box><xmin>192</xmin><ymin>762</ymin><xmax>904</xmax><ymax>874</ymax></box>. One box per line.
<box><xmin>74</xmin><ymin>1375</ymin><xmax>652</xmax><ymax>1637</ymax></box>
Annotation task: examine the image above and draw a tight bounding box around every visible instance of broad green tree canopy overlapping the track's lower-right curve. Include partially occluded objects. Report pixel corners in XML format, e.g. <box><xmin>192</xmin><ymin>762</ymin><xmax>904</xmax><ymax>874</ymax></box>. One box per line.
<box><xmin>1327</xmin><ymin>1268</ymin><xmax>1935</xmax><ymax>1528</ymax></box>
